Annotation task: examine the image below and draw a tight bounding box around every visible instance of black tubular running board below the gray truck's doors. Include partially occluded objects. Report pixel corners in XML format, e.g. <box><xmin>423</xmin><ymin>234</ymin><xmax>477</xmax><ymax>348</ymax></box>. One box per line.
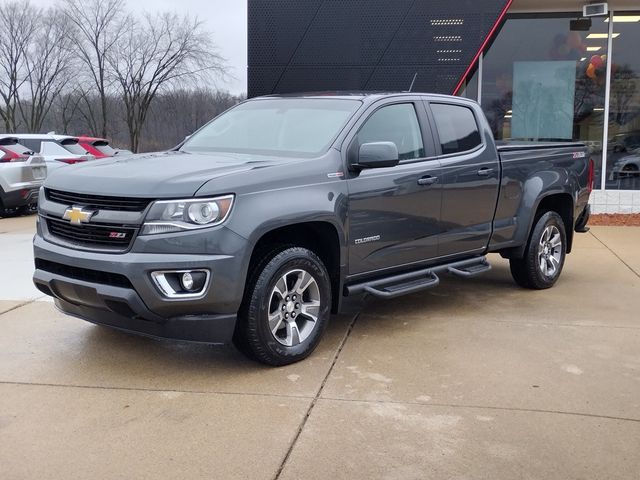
<box><xmin>346</xmin><ymin>257</ymin><xmax>491</xmax><ymax>298</ymax></box>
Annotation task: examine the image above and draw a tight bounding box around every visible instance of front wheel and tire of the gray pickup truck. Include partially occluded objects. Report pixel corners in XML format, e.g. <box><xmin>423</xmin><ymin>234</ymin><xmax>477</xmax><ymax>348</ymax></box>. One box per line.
<box><xmin>234</xmin><ymin>247</ymin><xmax>331</xmax><ymax>366</ymax></box>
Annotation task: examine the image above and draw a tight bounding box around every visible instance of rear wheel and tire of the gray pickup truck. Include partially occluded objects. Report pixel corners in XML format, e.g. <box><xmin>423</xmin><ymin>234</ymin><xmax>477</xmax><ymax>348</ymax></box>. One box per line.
<box><xmin>509</xmin><ymin>212</ymin><xmax>567</xmax><ymax>290</ymax></box>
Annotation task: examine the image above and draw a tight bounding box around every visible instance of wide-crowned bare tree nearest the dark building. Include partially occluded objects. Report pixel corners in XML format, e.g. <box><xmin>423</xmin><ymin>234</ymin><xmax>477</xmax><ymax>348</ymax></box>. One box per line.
<box><xmin>107</xmin><ymin>13</ymin><xmax>224</xmax><ymax>152</ymax></box>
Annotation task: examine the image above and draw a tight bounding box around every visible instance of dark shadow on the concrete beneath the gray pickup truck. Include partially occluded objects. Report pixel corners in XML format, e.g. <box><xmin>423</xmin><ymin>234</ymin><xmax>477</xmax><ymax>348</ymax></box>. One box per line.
<box><xmin>69</xmin><ymin>263</ymin><xmax>520</xmax><ymax>378</ymax></box>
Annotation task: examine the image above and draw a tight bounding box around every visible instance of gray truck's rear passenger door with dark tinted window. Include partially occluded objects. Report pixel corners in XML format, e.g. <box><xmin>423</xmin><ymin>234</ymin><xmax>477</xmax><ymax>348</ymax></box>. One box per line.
<box><xmin>426</xmin><ymin>101</ymin><xmax>500</xmax><ymax>257</ymax></box>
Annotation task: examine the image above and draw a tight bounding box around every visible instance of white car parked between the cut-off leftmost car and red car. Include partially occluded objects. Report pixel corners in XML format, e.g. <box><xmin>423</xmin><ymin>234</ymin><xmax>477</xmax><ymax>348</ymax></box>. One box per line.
<box><xmin>6</xmin><ymin>133</ymin><xmax>95</xmax><ymax>172</ymax></box>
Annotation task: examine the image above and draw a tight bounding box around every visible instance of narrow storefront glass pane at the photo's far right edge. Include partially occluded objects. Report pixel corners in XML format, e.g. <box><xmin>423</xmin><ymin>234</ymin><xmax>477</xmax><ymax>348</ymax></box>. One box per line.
<box><xmin>601</xmin><ymin>12</ymin><xmax>640</xmax><ymax>190</ymax></box>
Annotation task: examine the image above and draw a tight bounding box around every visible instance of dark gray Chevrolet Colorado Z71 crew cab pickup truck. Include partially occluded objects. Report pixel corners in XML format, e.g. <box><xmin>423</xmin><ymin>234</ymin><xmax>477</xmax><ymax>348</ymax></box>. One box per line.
<box><xmin>34</xmin><ymin>93</ymin><xmax>593</xmax><ymax>365</ymax></box>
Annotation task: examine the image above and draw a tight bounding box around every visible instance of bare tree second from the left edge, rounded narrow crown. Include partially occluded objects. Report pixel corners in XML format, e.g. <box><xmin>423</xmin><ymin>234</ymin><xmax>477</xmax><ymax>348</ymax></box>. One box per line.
<box><xmin>18</xmin><ymin>8</ymin><xmax>74</xmax><ymax>132</ymax></box>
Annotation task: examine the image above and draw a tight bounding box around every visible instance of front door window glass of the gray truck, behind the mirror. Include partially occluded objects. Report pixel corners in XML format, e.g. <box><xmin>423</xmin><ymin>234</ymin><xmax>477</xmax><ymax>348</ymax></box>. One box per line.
<box><xmin>355</xmin><ymin>103</ymin><xmax>425</xmax><ymax>160</ymax></box>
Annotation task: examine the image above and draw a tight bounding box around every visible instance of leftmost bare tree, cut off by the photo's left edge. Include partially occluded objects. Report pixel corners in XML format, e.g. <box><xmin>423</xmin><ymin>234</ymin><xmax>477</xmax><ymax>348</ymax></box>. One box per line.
<box><xmin>0</xmin><ymin>0</ymin><xmax>40</xmax><ymax>132</ymax></box>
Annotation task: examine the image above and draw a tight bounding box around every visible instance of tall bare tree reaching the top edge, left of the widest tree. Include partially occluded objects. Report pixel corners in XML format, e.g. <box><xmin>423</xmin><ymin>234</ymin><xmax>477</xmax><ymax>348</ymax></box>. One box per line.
<box><xmin>64</xmin><ymin>0</ymin><xmax>130</xmax><ymax>137</ymax></box>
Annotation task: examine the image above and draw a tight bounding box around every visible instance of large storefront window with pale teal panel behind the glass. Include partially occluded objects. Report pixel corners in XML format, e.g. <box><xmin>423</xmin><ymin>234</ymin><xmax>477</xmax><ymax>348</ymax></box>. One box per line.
<box><xmin>481</xmin><ymin>13</ymin><xmax>608</xmax><ymax>188</ymax></box>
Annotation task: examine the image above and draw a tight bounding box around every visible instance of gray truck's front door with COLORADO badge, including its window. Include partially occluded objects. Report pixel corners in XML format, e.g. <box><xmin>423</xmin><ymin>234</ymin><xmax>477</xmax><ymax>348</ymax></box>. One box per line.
<box><xmin>346</xmin><ymin>98</ymin><xmax>440</xmax><ymax>275</ymax></box>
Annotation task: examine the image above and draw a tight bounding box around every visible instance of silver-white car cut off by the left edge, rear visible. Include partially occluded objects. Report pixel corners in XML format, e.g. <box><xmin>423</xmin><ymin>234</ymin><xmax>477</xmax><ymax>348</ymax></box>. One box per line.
<box><xmin>0</xmin><ymin>135</ymin><xmax>47</xmax><ymax>217</ymax></box>
